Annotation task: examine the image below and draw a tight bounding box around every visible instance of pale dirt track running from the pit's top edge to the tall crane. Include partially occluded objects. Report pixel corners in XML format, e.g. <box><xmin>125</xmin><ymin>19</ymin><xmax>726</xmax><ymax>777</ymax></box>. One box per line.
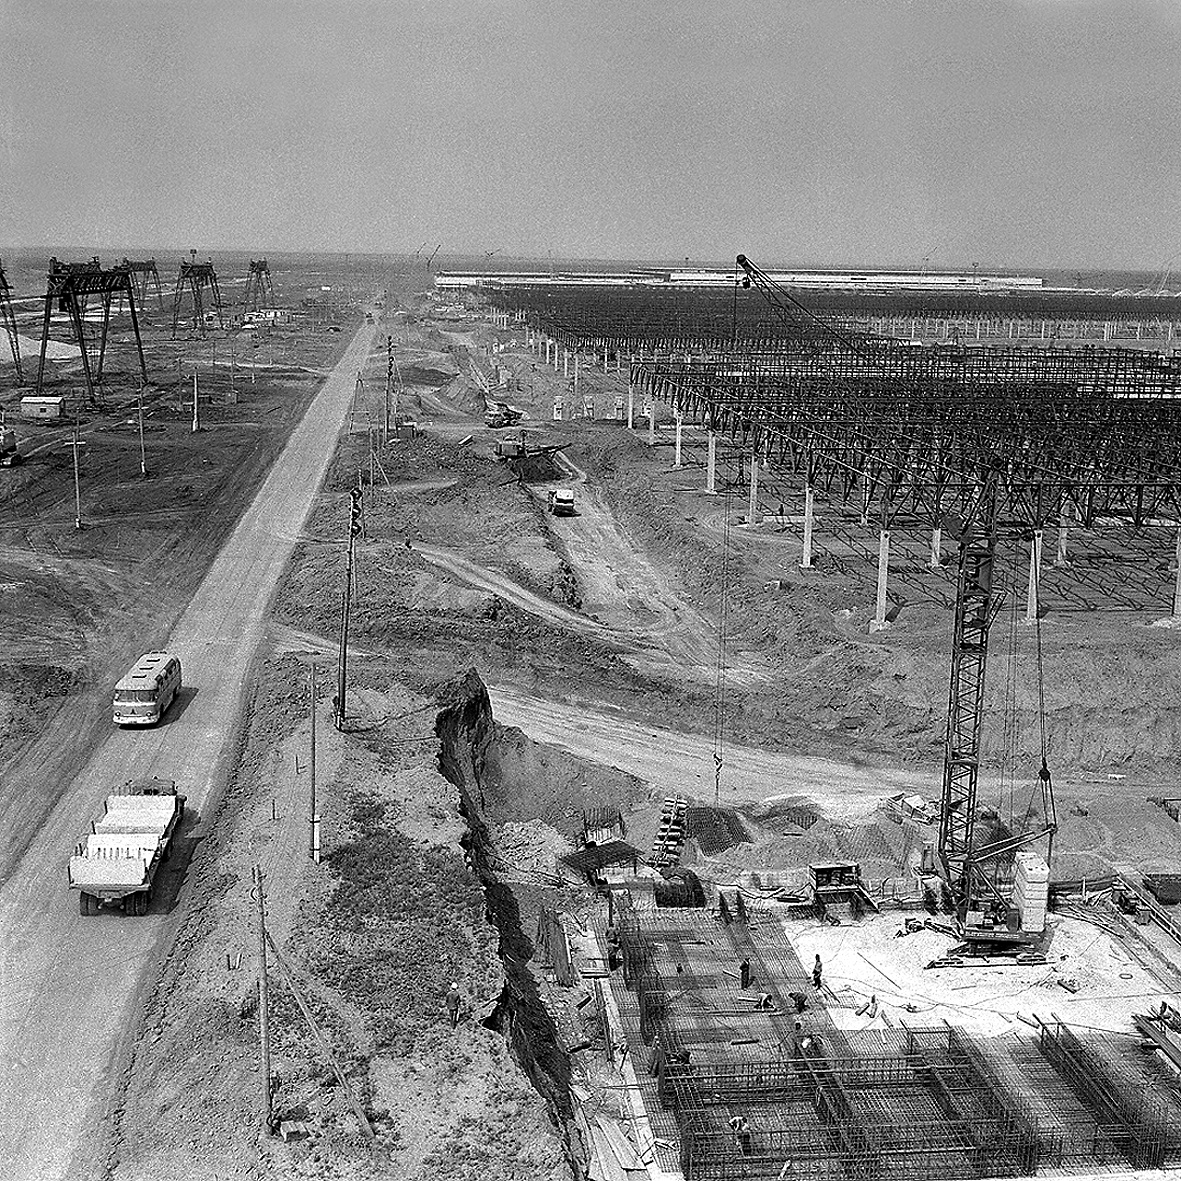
<box><xmin>489</xmin><ymin>686</ymin><xmax>939</xmax><ymax>820</ymax></box>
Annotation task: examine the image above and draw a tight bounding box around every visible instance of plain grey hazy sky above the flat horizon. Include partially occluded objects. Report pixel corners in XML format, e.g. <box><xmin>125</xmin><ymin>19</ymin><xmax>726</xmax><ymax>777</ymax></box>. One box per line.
<box><xmin>0</xmin><ymin>0</ymin><xmax>1181</xmax><ymax>269</ymax></box>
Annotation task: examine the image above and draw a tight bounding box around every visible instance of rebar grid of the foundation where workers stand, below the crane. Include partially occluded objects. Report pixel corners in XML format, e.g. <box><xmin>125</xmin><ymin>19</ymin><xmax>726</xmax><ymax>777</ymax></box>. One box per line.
<box><xmin>613</xmin><ymin>894</ymin><xmax>1181</xmax><ymax>1181</ymax></box>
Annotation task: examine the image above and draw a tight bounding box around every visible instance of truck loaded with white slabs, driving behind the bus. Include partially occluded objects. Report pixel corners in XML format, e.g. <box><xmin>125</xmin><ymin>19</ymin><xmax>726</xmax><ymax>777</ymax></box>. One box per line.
<box><xmin>68</xmin><ymin>778</ymin><xmax>184</xmax><ymax>915</ymax></box>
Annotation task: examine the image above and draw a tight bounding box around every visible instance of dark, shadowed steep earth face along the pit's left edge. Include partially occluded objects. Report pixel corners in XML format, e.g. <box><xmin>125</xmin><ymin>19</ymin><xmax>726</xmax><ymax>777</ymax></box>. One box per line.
<box><xmin>435</xmin><ymin>670</ymin><xmax>581</xmax><ymax>1176</ymax></box>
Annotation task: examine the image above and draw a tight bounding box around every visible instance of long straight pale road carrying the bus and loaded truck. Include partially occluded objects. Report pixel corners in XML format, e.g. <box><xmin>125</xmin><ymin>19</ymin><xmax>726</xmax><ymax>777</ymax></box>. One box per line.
<box><xmin>0</xmin><ymin>316</ymin><xmax>377</xmax><ymax>1181</ymax></box>
